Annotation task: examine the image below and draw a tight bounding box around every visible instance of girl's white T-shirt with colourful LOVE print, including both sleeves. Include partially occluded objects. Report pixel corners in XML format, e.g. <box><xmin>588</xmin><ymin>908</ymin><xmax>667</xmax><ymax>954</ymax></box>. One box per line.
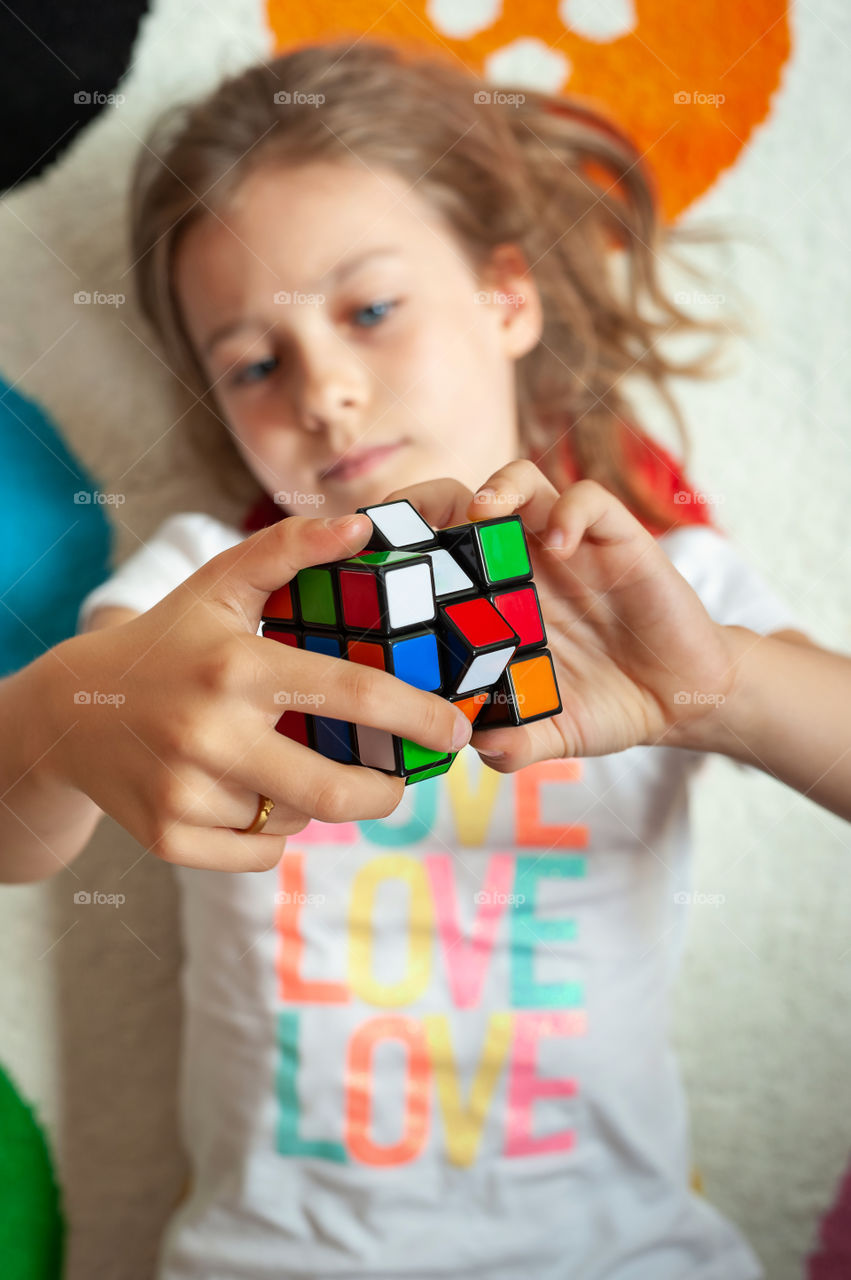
<box><xmin>79</xmin><ymin>513</ymin><xmax>799</xmax><ymax>1280</ymax></box>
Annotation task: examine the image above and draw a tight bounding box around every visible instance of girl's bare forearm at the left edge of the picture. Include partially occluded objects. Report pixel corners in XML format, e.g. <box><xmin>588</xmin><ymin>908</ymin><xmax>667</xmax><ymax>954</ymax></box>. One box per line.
<box><xmin>0</xmin><ymin>645</ymin><xmax>101</xmax><ymax>883</ymax></box>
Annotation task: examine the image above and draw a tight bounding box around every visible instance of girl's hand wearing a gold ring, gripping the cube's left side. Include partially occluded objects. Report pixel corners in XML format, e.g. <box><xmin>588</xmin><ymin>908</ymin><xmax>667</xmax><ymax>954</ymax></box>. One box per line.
<box><xmin>42</xmin><ymin>516</ymin><xmax>471</xmax><ymax>870</ymax></box>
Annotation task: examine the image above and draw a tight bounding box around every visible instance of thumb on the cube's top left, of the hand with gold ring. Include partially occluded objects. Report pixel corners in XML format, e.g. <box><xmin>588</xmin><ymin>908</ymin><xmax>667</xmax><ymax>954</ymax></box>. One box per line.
<box><xmin>195</xmin><ymin>516</ymin><xmax>372</xmax><ymax>632</ymax></box>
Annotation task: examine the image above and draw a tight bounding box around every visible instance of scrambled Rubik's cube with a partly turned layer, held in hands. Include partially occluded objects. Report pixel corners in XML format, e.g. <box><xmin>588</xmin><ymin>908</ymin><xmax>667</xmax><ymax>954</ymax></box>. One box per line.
<box><xmin>262</xmin><ymin>500</ymin><xmax>562</xmax><ymax>783</ymax></box>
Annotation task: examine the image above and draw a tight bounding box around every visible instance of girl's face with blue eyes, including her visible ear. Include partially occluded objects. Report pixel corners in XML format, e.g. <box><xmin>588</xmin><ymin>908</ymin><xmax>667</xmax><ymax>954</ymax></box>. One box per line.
<box><xmin>175</xmin><ymin>163</ymin><xmax>540</xmax><ymax>516</ymax></box>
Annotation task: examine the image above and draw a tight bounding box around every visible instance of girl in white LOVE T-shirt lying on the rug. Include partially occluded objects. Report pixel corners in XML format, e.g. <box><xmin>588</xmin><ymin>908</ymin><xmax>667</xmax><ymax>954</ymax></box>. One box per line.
<box><xmin>0</xmin><ymin>40</ymin><xmax>851</xmax><ymax>1280</ymax></box>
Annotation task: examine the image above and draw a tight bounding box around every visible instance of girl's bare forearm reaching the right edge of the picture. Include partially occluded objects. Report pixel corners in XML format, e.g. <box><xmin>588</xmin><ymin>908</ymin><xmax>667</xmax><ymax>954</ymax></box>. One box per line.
<box><xmin>668</xmin><ymin>627</ymin><xmax>851</xmax><ymax>819</ymax></box>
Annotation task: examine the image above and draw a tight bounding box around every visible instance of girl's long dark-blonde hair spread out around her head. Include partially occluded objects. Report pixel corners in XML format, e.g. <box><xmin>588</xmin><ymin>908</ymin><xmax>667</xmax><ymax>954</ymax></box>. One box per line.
<box><xmin>131</xmin><ymin>40</ymin><xmax>723</xmax><ymax>527</ymax></box>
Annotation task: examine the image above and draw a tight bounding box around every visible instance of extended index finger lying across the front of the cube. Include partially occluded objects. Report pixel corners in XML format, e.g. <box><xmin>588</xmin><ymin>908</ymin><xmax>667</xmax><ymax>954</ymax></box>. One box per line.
<box><xmin>242</xmin><ymin>636</ymin><xmax>471</xmax><ymax>751</ymax></box>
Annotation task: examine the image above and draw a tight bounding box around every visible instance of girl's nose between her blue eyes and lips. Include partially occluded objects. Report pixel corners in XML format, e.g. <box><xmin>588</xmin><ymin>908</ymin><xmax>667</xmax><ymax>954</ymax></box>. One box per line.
<box><xmin>294</xmin><ymin>334</ymin><xmax>369</xmax><ymax>434</ymax></box>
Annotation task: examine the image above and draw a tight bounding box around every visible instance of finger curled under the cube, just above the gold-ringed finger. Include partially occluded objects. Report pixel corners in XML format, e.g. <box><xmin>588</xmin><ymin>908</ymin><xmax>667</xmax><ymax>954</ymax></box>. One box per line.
<box><xmin>229</xmin><ymin>728</ymin><xmax>404</xmax><ymax>822</ymax></box>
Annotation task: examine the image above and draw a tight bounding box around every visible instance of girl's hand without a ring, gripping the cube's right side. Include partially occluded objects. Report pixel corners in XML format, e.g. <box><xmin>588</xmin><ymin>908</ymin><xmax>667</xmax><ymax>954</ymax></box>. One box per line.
<box><xmin>385</xmin><ymin>460</ymin><xmax>733</xmax><ymax>773</ymax></box>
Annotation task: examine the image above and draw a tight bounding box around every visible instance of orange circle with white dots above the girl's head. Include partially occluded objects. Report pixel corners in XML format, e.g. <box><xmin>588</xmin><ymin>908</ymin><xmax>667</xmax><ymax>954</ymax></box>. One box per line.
<box><xmin>267</xmin><ymin>0</ymin><xmax>791</xmax><ymax>219</ymax></box>
